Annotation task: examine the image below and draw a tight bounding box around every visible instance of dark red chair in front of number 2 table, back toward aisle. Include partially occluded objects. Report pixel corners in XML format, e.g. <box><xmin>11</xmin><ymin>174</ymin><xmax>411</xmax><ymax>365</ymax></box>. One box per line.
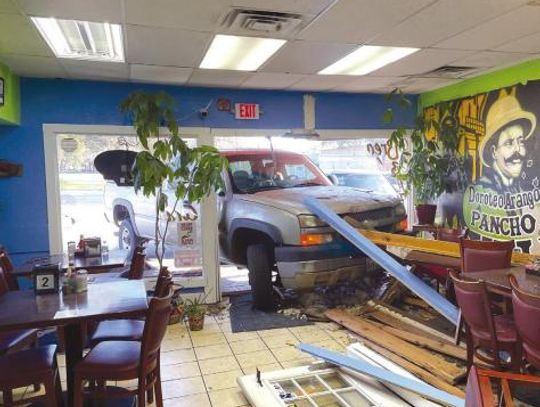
<box><xmin>74</xmin><ymin>287</ymin><xmax>173</xmax><ymax>407</ymax></box>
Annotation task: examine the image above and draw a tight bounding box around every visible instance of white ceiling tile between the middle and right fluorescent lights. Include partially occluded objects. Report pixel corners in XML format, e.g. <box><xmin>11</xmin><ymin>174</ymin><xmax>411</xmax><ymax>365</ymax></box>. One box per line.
<box><xmin>262</xmin><ymin>41</ymin><xmax>358</xmax><ymax>74</ymax></box>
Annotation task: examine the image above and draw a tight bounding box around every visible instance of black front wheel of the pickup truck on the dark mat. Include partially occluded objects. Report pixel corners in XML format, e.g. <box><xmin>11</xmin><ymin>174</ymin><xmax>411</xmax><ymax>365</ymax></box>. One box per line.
<box><xmin>247</xmin><ymin>244</ymin><xmax>275</xmax><ymax>311</ymax></box>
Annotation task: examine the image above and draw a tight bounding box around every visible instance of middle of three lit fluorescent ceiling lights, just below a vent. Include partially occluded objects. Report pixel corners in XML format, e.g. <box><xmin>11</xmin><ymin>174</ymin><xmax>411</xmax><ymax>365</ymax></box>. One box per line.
<box><xmin>199</xmin><ymin>34</ymin><xmax>287</xmax><ymax>71</ymax></box>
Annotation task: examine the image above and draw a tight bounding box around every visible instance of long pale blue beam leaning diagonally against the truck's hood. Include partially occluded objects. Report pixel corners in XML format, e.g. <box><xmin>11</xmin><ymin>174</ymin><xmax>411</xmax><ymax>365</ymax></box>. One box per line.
<box><xmin>304</xmin><ymin>198</ymin><xmax>458</xmax><ymax>325</ymax></box>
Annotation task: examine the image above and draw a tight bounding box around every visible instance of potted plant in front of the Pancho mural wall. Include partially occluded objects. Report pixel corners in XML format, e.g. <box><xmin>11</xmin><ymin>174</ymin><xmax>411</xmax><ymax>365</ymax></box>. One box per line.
<box><xmin>383</xmin><ymin>89</ymin><xmax>466</xmax><ymax>224</ymax></box>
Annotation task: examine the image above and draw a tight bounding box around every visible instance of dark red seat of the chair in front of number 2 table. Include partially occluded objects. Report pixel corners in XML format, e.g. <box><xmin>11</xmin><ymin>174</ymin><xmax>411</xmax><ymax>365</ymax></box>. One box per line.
<box><xmin>76</xmin><ymin>341</ymin><xmax>141</xmax><ymax>380</ymax></box>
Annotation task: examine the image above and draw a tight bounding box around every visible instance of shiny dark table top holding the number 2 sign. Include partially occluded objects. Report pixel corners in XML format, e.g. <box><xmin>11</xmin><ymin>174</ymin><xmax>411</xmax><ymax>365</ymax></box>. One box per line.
<box><xmin>0</xmin><ymin>279</ymin><xmax>148</xmax><ymax>332</ymax></box>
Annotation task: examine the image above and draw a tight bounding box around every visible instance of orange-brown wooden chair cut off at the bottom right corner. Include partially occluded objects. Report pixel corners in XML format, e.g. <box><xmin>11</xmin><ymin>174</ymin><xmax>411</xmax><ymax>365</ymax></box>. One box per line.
<box><xmin>465</xmin><ymin>366</ymin><xmax>540</xmax><ymax>407</ymax></box>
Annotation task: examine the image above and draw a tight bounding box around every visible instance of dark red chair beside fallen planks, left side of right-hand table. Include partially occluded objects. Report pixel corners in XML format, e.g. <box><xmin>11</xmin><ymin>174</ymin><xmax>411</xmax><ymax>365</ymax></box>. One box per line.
<box><xmin>450</xmin><ymin>272</ymin><xmax>521</xmax><ymax>370</ymax></box>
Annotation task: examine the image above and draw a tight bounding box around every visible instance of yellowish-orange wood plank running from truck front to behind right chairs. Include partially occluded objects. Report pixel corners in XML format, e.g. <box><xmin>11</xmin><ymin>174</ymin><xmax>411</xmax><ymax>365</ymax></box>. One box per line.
<box><xmin>357</xmin><ymin>228</ymin><xmax>540</xmax><ymax>265</ymax></box>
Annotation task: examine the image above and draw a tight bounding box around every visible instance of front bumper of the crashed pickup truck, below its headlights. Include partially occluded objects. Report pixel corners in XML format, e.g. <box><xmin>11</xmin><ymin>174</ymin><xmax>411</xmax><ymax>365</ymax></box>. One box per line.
<box><xmin>275</xmin><ymin>241</ymin><xmax>367</xmax><ymax>289</ymax></box>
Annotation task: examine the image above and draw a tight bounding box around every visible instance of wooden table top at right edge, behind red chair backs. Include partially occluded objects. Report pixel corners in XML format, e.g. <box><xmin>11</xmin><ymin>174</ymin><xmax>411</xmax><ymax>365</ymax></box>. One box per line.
<box><xmin>467</xmin><ymin>266</ymin><xmax>540</xmax><ymax>295</ymax></box>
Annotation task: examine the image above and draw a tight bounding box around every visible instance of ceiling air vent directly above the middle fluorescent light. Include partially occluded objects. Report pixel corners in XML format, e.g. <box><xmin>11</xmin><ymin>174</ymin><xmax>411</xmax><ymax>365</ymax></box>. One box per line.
<box><xmin>222</xmin><ymin>9</ymin><xmax>304</xmax><ymax>36</ymax></box>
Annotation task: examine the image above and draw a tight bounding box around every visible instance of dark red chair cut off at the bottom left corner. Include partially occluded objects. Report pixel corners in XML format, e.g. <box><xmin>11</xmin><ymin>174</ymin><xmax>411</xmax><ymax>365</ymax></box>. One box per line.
<box><xmin>0</xmin><ymin>345</ymin><xmax>62</xmax><ymax>407</ymax></box>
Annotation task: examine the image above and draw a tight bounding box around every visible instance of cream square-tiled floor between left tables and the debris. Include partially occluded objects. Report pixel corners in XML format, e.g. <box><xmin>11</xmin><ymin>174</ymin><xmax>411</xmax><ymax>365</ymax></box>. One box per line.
<box><xmin>8</xmin><ymin>312</ymin><xmax>354</xmax><ymax>407</ymax></box>
